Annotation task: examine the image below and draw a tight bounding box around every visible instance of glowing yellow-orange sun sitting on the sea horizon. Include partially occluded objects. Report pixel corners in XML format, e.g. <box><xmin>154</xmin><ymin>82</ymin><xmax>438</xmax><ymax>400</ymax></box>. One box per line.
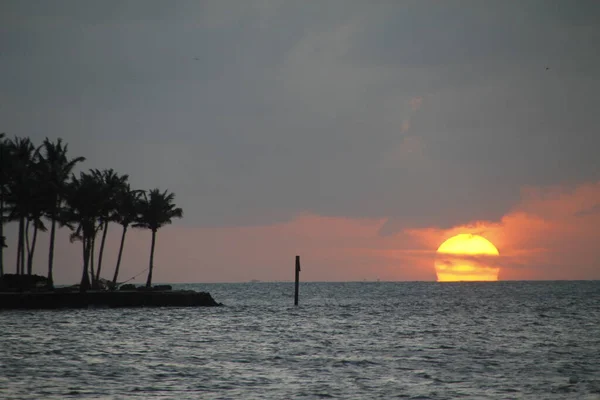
<box><xmin>435</xmin><ymin>233</ymin><xmax>500</xmax><ymax>282</ymax></box>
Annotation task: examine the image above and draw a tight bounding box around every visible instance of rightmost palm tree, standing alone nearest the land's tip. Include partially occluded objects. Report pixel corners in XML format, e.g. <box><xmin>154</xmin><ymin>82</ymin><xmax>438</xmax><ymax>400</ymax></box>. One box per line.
<box><xmin>134</xmin><ymin>189</ymin><xmax>183</xmax><ymax>288</ymax></box>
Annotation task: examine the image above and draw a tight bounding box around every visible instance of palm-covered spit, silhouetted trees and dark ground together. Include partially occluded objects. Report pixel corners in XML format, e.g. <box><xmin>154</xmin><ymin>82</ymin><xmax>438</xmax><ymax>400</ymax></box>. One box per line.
<box><xmin>0</xmin><ymin>133</ymin><xmax>217</xmax><ymax>308</ymax></box>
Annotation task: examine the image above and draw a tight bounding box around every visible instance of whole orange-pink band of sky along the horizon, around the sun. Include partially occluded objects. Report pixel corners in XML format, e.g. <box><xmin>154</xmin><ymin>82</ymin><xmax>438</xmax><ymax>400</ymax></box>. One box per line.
<box><xmin>6</xmin><ymin>182</ymin><xmax>600</xmax><ymax>283</ymax></box>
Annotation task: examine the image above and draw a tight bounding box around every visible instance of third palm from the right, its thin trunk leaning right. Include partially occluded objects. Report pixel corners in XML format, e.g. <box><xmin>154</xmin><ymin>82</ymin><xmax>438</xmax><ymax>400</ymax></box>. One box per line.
<box><xmin>92</xmin><ymin>168</ymin><xmax>129</xmax><ymax>287</ymax></box>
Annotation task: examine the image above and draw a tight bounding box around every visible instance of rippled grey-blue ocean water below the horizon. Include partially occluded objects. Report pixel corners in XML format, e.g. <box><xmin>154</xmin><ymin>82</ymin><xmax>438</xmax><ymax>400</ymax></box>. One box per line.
<box><xmin>0</xmin><ymin>281</ymin><xmax>600</xmax><ymax>399</ymax></box>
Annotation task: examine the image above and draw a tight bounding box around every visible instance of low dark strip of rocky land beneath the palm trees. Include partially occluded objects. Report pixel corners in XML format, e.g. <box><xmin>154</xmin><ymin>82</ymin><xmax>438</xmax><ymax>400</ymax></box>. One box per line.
<box><xmin>0</xmin><ymin>290</ymin><xmax>221</xmax><ymax>310</ymax></box>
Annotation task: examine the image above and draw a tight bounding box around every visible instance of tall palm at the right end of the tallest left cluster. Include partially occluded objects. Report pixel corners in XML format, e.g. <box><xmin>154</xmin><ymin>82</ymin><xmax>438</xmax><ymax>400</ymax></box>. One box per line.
<box><xmin>40</xmin><ymin>138</ymin><xmax>85</xmax><ymax>286</ymax></box>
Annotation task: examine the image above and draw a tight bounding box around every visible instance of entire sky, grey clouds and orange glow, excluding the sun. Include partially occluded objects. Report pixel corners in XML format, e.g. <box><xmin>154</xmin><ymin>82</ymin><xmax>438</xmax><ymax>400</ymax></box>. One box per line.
<box><xmin>0</xmin><ymin>0</ymin><xmax>600</xmax><ymax>283</ymax></box>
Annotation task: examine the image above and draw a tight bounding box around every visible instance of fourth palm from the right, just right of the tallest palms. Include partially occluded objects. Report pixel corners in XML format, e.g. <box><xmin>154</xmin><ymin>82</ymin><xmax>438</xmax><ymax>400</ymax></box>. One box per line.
<box><xmin>61</xmin><ymin>172</ymin><xmax>104</xmax><ymax>292</ymax></box>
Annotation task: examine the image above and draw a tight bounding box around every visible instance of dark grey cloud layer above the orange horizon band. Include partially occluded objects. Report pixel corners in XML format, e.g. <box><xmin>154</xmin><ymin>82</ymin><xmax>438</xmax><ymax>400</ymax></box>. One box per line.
<box><xmin>0</xmin><ymin>1</ymin><xmax>600</xmax><ymax>234</ymax></box>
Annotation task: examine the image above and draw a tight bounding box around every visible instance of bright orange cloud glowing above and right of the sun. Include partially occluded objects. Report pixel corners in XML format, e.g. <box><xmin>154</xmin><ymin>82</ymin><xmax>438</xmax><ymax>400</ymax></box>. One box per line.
<box><xmin>410</xmin><ymin>183</ymin><xmax>600</xmax><ymax>280</ymax></box>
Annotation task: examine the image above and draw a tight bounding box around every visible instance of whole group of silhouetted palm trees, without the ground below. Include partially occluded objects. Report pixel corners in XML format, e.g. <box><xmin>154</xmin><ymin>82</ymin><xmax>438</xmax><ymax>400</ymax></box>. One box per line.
<box><xmin>0</xmin><ymin>133</ymin><xmax>183</xmax><ymax>291</ymax></box>
